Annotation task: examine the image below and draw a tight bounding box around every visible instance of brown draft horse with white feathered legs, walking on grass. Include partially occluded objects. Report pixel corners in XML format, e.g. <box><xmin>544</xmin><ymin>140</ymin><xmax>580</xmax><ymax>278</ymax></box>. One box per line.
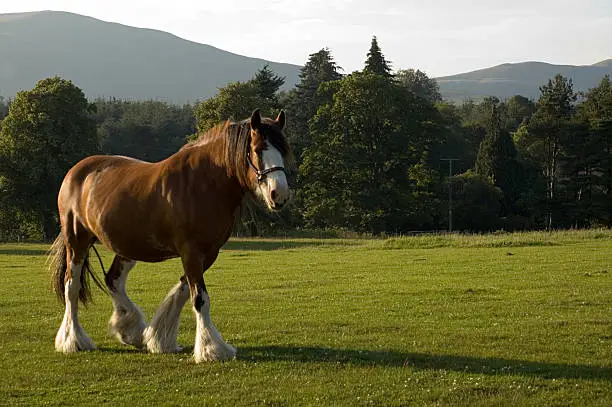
<box><xmin>50</xmin><ymin>110</ymin><xmax>291</xmax><ymax>362</ymax></box>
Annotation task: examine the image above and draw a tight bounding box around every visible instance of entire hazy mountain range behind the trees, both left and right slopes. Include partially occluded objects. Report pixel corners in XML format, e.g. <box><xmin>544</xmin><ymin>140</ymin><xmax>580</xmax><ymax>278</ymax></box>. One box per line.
<box><xmin>0</xmin><ymin>11</ymin><xmax>612</xmax><ymax>103</ymax></box>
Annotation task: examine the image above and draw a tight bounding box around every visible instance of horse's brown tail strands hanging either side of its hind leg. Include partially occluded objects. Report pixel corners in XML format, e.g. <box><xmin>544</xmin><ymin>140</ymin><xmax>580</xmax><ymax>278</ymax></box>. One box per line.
<box><xmin>47</xmin><ymin>233</ymin><xmax>107</xmax><ymax>305</ymax></box>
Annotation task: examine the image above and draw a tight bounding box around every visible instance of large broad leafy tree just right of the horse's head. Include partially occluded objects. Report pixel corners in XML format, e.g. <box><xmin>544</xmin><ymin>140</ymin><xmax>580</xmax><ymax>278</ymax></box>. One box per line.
<box><xmin>299</xmin><ymin>72</ymin><xmax>437</xmax><ymax>233</ymax></box>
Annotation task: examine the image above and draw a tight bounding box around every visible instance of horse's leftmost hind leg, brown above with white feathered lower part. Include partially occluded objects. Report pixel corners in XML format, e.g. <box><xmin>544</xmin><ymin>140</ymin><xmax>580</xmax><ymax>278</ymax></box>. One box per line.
<box><xmin>55</xmin><ymin>223</ymin><xmax>96</xmax><ymax>353</ymax></box>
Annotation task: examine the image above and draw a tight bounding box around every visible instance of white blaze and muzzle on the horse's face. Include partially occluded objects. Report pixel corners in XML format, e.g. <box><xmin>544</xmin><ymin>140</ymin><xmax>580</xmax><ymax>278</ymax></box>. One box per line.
<box><xmin>260</xmin><ymin>145</ymin><xmax>290</xmax><ymax>209</ymax></box>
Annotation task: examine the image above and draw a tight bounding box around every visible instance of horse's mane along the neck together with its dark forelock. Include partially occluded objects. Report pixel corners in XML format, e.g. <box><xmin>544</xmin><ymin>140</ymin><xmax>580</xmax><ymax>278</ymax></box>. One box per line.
<box><xmin>181</xmin><ymin>118</ymin><xmax>294</xmax><ymax>185</ymax></box>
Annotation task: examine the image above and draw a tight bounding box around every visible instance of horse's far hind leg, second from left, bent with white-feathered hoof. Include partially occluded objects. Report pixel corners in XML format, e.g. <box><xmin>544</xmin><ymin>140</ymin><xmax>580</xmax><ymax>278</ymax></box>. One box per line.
<box><xmin>105</xmin><ymin>256</ymin><xmax>147</xmax><ymax>348</ymax></box>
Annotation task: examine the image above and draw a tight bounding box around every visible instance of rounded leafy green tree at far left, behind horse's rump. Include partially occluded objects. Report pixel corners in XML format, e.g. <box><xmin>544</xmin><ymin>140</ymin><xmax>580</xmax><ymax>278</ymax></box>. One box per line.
<box><xmin>0</xmin><ymin>77</ymin><xmax>99</xmax><ymax>239</ymax></box>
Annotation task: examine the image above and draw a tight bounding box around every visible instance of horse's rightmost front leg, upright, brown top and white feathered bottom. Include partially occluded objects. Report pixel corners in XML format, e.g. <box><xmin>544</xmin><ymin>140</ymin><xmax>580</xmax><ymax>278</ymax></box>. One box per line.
<box><xmin>182</xmin><ymin>251</ymin><xmax>236</xmax><ymax>363</ymax></box>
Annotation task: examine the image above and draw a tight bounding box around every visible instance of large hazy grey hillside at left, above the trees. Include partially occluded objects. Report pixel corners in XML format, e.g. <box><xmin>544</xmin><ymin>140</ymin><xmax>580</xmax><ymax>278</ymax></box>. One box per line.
<box><xmin>0</xmin><ymin>11</ymin><xmax>300</xmax><ymax>103</ymax></box>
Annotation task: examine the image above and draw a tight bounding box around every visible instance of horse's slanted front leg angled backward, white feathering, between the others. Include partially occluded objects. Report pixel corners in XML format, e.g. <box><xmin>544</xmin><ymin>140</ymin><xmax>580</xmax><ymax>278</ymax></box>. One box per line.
<box><xmin>144</xmin><ymin>276</ymin><xmax>189</xmax><ymax>353</ymax></box>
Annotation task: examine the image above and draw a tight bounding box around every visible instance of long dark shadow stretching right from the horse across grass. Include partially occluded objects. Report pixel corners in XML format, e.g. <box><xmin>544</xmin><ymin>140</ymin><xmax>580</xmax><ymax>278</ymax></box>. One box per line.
<box><xmin>237</xmin><ymin>346</ymin><xmax>612</xmax><ymax>380</ymax></box>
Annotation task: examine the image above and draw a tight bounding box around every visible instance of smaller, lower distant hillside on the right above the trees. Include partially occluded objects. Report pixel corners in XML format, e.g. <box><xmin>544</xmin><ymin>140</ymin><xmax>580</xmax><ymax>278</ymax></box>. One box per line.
<box><xmin>436</xmin><ymin>59</ymin><xmax>612</xmax><ymax>101</ymax></box>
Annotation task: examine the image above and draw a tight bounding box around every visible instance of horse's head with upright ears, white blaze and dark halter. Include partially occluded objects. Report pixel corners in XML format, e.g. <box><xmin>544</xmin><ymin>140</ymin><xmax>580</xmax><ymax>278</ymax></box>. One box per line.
<box><xmin>247</xmin><ymin>109</ymin><xmax>291</xmax><ymax>211</ymax></box>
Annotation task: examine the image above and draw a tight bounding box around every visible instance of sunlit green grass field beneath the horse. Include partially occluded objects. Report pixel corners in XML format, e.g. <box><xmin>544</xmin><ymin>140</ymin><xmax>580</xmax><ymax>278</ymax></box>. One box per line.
<box><xmin>0</xmin><ymin>230</ymin><xmax>612</xmax><ymax>406</ymax></box>
